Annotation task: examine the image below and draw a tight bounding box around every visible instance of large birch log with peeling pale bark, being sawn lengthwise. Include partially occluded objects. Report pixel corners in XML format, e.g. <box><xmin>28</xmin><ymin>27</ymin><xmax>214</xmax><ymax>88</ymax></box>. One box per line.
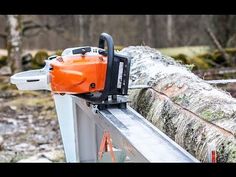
<box><xmin>121</xmin><ymin>46</ymin><xmax>236</xmax><ymax>162</ymax></box>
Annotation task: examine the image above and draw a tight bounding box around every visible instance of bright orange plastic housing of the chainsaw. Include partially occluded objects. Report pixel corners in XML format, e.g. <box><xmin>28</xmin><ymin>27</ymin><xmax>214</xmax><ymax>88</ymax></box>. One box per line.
<box><xmin>50</xmin><ymin>54</ymin><xmax>107</xmax><ymax>94</ymax></box>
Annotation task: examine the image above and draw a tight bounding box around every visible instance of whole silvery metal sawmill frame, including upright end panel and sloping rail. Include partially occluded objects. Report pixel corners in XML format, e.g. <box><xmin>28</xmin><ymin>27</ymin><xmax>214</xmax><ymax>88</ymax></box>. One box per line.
<box><xmin>54</xmin><ymin>95</ymin><xmax>199</xmax><ymax>162</ymax></box>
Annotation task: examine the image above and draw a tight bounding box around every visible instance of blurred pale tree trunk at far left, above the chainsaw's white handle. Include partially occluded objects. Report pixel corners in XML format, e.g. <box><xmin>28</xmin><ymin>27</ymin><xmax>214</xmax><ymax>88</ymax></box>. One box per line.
<box><xmin>7</xmin><ymin>15</ymin><xmax>22</xmax><ymax>73</ymax></box>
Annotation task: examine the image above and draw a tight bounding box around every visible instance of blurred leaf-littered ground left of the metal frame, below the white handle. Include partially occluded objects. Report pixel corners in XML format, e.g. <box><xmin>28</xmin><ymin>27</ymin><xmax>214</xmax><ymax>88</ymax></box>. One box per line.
<box><xmin>0</xmin><ymin>77</ymin><xmax>65</xmax><ymax>162</ymax></box>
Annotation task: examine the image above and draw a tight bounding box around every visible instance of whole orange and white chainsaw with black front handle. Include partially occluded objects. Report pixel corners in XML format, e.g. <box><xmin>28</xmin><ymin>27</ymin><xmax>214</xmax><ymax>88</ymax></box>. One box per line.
<box><xmin>11</xmin><ymin>33</ymin><xmax>130</xmax><ymax>109</ymax></box>
